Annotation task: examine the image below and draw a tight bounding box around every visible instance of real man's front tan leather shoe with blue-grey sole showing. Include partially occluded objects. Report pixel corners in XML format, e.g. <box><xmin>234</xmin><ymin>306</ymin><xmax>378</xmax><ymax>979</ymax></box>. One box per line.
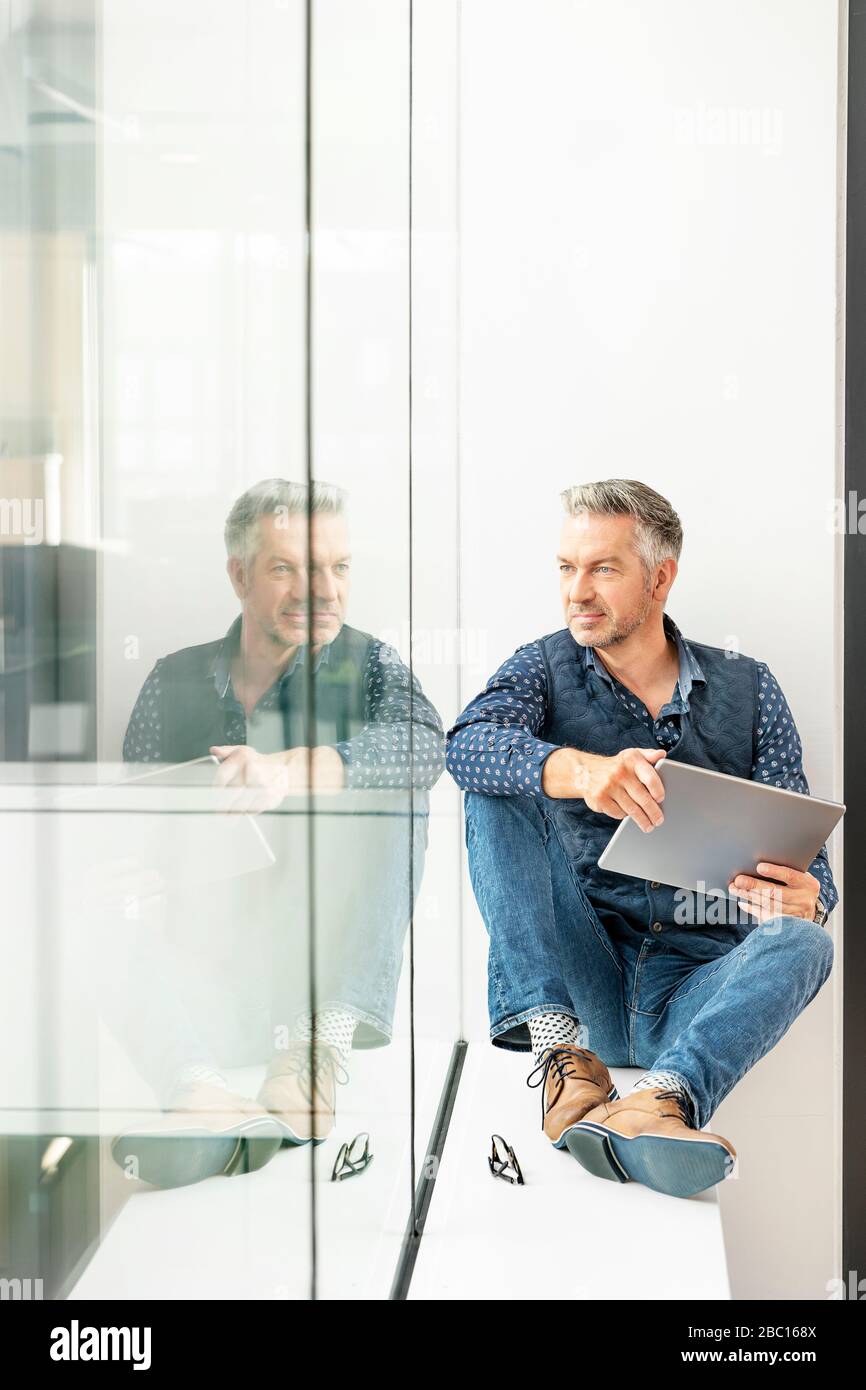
<box><xmin>567</xmin><ymin>1088</ymin><xmax>737</xmax><ymax>1197</ymax></box>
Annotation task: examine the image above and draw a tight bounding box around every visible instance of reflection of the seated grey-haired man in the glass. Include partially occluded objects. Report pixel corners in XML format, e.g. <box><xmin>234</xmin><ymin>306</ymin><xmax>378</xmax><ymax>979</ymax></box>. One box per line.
<box><xmin>108</xmin><ymin>478</ymin><xmax>443</xmax><ymax>1176</ymax></box>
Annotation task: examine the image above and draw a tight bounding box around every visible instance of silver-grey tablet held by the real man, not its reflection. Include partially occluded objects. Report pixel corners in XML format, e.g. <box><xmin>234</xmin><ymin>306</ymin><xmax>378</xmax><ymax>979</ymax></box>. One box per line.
<box><xmin>599</xmin><ymin>758</ymin><xmax>845</xmax><ymax>901</ymax></box>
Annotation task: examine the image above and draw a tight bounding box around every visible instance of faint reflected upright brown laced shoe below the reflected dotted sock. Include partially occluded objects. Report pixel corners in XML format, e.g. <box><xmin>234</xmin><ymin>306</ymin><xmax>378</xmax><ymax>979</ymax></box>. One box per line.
<box><xmin>257</xmin><ymin>1041</ymin><xmax>349</xmax><ymax>1145</ymax></box>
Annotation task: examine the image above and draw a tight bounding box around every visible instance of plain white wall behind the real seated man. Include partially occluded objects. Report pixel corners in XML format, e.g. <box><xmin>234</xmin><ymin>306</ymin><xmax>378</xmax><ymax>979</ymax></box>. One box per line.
<box><xmin>460</xmin><ymin>0</ymin><xmax>841</xmax><ymax>1298</ymax></box>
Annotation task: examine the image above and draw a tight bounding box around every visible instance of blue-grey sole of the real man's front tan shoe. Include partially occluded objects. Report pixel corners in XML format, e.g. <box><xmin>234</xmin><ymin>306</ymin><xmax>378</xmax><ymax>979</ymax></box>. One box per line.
<box><xmin>566</xmin><ymin>1120</ymin><xmax>734</xmax><ymax>1197</ymax></box>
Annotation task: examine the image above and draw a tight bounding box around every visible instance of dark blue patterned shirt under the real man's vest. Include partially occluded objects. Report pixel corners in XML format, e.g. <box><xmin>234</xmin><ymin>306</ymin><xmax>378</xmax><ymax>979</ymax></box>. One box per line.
<box><xmin>445</xmin><ymin>613</ymin><xmax>838</xmax><ymax>912</ymax></box>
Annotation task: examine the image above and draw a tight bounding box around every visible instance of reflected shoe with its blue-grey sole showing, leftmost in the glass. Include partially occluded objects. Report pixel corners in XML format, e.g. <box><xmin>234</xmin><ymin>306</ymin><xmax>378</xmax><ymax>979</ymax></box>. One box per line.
<box><xmin>111</xmin><ymin>1084</ymin><xmax>282</xmax><ymax>1187</ymax></box>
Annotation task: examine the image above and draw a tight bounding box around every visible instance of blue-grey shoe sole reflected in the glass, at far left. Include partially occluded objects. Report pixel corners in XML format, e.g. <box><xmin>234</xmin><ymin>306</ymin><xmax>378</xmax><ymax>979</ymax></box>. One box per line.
<box><xmin>111</xmin><ymin>1116</ymin><xmax>282</xmax><ymax>1188</ymax></box>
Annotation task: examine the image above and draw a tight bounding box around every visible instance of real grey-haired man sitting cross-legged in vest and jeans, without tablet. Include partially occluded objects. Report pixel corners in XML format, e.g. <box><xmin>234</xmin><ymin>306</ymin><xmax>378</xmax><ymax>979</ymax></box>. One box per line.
<box><xmin>446</xmin><ymin>478</ymin><xmax>838</xmax><ymax>1197</ymax></box>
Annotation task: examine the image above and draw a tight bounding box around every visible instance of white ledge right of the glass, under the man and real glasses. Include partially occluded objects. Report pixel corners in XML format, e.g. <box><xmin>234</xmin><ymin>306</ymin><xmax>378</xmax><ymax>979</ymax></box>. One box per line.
<box><xmin>409</xmin><ymin>1041</ymin><xmax>731</xmax><ymax>1301</ymax></box>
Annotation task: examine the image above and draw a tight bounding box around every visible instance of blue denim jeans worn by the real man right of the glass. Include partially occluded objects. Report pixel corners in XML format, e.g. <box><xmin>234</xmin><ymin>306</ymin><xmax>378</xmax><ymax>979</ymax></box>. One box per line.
<box><xmin>464</xmin><ymin>792</ymin><xmax>833</xmax><ymax>1127</ymax></box>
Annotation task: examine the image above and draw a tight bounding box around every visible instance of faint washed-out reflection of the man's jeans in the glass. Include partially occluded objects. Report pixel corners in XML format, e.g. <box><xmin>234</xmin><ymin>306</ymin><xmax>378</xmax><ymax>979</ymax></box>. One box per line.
<box><xmin>100</xmin><ymin>792</ymin><xmax>428</xmax><ymax>1099</ymax></box>
